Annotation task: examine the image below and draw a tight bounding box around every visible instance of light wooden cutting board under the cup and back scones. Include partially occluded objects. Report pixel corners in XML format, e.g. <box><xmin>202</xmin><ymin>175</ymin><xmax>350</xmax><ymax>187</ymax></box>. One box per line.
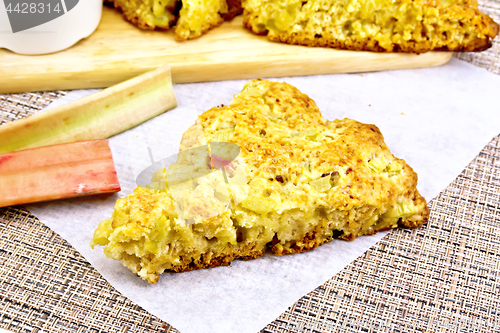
<box><xmin>0</xmin><ymin>7</ymin><xmax>452</xmax><ymax>93</ymax></box>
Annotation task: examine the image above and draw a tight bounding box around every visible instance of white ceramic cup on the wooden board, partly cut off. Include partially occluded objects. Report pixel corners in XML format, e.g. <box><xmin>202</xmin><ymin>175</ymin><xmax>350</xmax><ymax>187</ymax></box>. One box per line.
<box><xmin>0</xmin><ymin>0</ymin><xmax>102</xmax><ymax>54</ymax></box>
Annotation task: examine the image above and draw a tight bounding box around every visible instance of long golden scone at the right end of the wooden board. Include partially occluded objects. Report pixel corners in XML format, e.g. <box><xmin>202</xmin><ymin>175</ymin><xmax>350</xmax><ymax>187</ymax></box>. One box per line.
<box><xmin>243</xmin><ymin>0</ymin><xmax>498</xmax><ymax>53</ymax></box>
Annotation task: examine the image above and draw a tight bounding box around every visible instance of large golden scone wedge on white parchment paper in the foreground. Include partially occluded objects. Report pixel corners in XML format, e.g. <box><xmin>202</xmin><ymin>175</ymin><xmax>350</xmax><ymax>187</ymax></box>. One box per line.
<box><xmin>91</xmin><ymin>80</ymin><xmax>429</xmax><ymax>283</ymax></box>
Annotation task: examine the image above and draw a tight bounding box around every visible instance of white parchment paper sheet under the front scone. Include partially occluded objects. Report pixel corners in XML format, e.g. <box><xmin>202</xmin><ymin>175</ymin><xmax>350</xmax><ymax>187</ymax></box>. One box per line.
<box><xmin>27</xmin><ymin>59</ymin><xmax>500</xmax><ymax>333</ymax></box>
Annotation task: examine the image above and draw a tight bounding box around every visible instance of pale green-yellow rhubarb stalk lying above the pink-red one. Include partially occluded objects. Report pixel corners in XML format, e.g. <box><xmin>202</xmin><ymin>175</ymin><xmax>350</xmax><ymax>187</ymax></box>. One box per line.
<box><xmin>0</xmin><ymin>66</ymin><xmax>177</xmax><ymax>153</ymax></box>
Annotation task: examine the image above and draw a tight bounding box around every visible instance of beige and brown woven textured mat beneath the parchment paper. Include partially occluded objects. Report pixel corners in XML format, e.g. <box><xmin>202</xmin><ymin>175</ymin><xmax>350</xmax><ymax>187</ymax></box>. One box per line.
<box><xmin>0</xmin><ymin>5</ymin><xmax>500</xmax><ymax>333</ymax></box>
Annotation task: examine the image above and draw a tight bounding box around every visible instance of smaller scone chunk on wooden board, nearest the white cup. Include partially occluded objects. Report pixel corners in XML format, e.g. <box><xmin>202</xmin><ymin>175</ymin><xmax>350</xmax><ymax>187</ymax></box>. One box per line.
<box><xmin>104</xmin><ymin>0</ymin><xmax>243</xmax><ymax>41</ymax></box>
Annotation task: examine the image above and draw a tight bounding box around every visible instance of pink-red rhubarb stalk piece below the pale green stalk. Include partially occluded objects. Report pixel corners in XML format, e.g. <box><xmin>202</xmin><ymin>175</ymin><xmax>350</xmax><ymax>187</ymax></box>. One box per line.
<box><xmin>0</xmin><ymin>140</ymin><xmax>120</xmax><ymax>207</ymax></box>
